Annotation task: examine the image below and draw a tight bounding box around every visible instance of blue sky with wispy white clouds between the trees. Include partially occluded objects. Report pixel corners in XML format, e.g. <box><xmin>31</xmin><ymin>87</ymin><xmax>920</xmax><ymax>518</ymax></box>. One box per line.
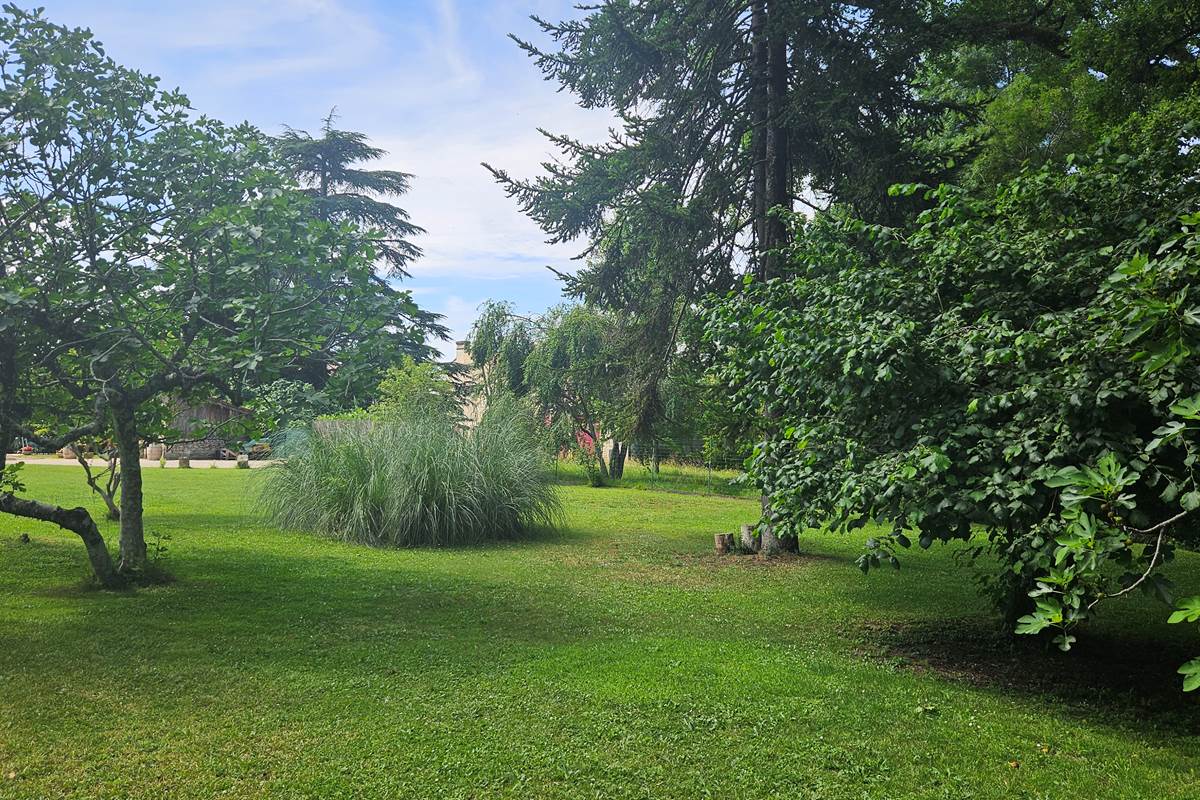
<box><xmin>37</xmin><ymin>0</ymin><xmax>610</xmax><ymax>353</ymax></box>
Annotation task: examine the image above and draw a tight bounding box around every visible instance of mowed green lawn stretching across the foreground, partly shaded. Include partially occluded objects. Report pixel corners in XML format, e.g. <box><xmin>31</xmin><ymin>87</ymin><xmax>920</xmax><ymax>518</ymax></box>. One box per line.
<box><xmin>0</xmin><ymin>467</ymin><xmax>1200</xmax><ymax>800</ymax></box>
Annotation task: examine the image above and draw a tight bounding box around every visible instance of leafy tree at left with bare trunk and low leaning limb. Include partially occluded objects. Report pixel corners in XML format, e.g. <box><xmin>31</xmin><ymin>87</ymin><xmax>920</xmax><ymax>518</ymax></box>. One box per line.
<box><xmin>0</xmin><ymin>6</ymin><xmax>441</xmax><ymax>583</ymax></box>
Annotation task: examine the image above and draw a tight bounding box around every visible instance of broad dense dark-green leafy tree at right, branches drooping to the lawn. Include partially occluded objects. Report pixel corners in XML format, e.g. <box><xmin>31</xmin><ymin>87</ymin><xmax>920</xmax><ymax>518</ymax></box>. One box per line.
<box><xmin>709</xmin><ymin>97</ymin><xmax>1200</xmax><ymax>681</ymax></box>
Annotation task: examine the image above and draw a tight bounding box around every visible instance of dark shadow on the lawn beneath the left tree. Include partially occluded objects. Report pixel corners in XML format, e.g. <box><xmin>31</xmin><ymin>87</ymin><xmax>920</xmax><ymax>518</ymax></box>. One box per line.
<box><xmin>0</xmin><ymin>534</ymin><xmax>608</xmax><ymax>674</ymax></box>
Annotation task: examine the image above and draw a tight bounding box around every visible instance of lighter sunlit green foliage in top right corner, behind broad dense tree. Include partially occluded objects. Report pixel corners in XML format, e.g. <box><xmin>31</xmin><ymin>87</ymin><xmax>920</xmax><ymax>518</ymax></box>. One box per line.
<box><xmin>916</xmin><ymin>0</ymin><xmax>1200</xmax><ymax>190</ymax></box>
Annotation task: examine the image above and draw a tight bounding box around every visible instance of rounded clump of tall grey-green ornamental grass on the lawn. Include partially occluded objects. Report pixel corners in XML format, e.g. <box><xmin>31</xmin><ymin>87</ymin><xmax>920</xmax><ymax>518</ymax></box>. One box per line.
<box><xmin>260</xmin><ymin>403</ymin><xmax>560</xmax><ymax>547</ymax></box>
